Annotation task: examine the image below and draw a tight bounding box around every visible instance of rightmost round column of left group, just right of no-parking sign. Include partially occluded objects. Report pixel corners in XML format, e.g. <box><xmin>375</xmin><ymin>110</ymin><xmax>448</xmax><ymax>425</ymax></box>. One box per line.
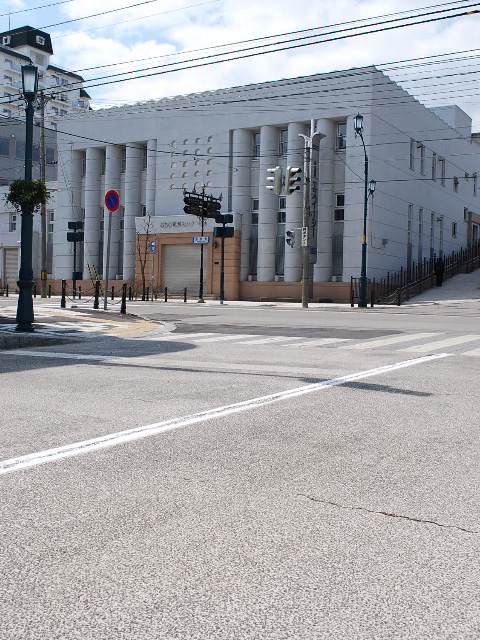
<box><xmin>123</xmin><ymin>144</ymin><xmax>142</xmax><ymax>280</ymax></box>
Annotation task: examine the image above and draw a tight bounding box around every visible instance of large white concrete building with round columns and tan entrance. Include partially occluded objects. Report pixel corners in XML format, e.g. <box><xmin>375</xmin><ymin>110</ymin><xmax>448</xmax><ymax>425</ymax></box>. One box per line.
<box><xmin>53</xmin><ymin>67</ymin><xmax>480</xmax><ymax>300</ymax></box>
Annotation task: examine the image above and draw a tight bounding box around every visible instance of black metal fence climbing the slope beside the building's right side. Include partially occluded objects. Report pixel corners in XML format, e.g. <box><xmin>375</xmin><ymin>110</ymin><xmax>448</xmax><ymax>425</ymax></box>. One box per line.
<box><xmin>350</xmin><ymin>242</ymin><xmax>480</xmax><ymax>306</ymax></box>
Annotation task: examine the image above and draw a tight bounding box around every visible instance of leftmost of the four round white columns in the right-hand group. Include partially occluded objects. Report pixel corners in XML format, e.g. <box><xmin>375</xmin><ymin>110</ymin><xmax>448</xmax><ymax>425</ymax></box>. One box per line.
<box><xmin>232</xmin><ymin>129</ymin><xmax>252</xmax><ymax>281</ymax></box>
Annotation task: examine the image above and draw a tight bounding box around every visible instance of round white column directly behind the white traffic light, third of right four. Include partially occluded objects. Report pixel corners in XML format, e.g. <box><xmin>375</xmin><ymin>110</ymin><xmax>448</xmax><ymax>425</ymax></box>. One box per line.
<box><xmin>284</xmin><ymin>122</ymin><xmax>306</xmax><ymax>282</ymax></box>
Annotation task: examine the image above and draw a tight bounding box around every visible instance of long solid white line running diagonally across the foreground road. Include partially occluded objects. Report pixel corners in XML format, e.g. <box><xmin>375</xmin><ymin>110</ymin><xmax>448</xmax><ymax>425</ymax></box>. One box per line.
<box><xmin>0</xmin><ymin>353</ymin><xmax>450</xmax><ymax>475</ymax></box>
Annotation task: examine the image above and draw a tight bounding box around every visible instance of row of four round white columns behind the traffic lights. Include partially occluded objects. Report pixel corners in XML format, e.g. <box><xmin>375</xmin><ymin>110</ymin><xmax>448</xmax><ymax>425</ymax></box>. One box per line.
<box><xmin>232</xmin><ymin>119</ymin><xmax>336</xmax><ymax>282</ymax></box>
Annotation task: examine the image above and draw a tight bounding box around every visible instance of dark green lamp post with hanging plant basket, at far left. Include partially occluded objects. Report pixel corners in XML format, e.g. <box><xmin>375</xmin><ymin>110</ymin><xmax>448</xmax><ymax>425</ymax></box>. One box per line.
<box><xmin>16</xmin><ymin>64</ymin><xmax>38</xmax><ymax>331</ymax></box>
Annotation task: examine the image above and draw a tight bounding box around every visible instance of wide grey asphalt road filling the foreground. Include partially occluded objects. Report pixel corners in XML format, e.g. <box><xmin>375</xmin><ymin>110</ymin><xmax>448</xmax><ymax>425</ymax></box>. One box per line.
<box><xmin>0</xmin><ymin>303</ymin><xmax>480</xmax><ymax>640</ymax></box>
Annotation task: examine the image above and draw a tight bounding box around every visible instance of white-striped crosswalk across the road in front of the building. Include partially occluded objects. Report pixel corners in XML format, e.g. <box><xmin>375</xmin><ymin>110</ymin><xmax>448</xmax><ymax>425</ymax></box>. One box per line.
<box><xmin>151</xmin><ymin>332</ymin><xmax>480</xmax><ymax>357</ymax></box>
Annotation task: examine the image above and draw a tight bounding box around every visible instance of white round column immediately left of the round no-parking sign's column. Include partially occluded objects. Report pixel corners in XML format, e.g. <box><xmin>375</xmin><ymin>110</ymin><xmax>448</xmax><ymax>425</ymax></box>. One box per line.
<box><xmin>83</xmin><ymin>147</ymin><xmax>103</xmax><ymax>278</ymax></box>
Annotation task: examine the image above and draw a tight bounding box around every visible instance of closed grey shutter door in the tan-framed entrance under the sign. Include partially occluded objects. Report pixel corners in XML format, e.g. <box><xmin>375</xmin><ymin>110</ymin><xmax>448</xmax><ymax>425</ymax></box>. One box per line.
<box><xmin>162</xmin><ymin>244</ymin><xmax>208</xmax><ymax>295</ymax></box>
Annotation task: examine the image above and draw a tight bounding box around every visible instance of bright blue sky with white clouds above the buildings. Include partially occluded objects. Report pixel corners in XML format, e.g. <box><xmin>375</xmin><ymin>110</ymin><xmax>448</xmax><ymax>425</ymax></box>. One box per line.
<box><xmin>0</xmin><ymin>0</ymin><xmax>480</xmax><ymax>131</ymax></box>
